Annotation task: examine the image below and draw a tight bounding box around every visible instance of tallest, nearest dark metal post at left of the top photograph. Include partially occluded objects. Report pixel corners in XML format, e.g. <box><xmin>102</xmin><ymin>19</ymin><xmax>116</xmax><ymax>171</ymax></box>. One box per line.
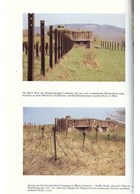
<box><xmin>27</xmin><ymin>13</ymin><xmax>34</xmax><ymax>81</ymax></box>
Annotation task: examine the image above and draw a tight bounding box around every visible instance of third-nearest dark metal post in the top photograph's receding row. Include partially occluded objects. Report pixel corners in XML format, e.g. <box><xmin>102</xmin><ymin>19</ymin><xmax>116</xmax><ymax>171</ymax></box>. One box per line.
<box><xmin>49</xmin><ymin>25</ymin><xmax>53</xmax><ymax>69</ymax></box>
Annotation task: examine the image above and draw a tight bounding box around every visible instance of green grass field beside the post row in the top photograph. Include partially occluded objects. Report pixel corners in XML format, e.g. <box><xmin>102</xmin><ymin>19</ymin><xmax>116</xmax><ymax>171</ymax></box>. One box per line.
<box><xmin>23</xmin><ymin>40</ymin><xmax>125</xmax><ymax>81</ymax></box>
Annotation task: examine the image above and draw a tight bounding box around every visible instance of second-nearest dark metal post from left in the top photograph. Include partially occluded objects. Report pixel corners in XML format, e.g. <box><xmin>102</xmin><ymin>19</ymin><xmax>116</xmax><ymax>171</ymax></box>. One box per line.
<box><xmin>40</xmin><ymin>20</ymin><xmax>45</xmax><ymax>76</ymax></box>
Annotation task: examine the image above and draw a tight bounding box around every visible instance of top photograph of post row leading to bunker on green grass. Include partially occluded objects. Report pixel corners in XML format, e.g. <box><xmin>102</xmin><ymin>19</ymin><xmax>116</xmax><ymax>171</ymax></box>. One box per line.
<box><xmin>22</xmin><ymin>13</ymin><xmax>125</xmax><ymax>82</ymax></box>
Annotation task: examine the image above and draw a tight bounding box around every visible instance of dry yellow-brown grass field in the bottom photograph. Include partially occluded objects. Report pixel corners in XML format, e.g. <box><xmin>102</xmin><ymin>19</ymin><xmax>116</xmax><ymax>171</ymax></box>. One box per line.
<box><xmin>23</xmin><ymin>126</ymin><xmax>125</xmax><ymax>176</ymax></box>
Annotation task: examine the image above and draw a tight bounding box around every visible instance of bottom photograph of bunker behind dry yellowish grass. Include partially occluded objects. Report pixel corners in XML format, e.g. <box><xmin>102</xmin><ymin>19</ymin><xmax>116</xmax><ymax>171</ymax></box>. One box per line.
<box><xmin>23</xmin><ymin>107</ymin><xmax>125</xmax><ymax>176</ymax></box>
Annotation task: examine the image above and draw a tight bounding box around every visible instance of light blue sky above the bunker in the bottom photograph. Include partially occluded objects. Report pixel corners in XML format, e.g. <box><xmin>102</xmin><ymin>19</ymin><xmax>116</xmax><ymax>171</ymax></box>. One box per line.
<box><xmin>23</xmin><ymin>107</ymin><xmax>121</xmax><ymax>124</ymax></box>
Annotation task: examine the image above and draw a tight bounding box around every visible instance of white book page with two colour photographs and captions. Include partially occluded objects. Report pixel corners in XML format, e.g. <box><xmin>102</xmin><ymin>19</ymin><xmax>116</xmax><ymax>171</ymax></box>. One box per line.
<box><xmin>6</xmin><ymin>0</ymin><xmax>134</xmax><ymax>194</ymax></box>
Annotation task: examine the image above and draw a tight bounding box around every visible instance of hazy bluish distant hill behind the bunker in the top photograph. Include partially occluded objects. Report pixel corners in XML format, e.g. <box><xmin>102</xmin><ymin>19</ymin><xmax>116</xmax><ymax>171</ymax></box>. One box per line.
<box><xmin>23</xmin><ymin>24</ymin><xmax>125</xmax><ymax>41</ymax></box>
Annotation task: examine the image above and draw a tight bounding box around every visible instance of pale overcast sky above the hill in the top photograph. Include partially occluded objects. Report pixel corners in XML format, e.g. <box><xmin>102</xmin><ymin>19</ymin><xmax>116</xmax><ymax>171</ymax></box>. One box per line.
<box><xmin>23</xmin><ymin>13</ymin><xmax>125</xmax><ymax>29</ymax></box>
